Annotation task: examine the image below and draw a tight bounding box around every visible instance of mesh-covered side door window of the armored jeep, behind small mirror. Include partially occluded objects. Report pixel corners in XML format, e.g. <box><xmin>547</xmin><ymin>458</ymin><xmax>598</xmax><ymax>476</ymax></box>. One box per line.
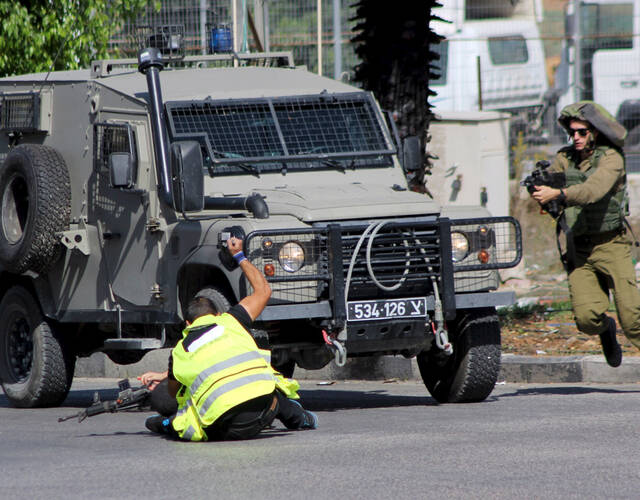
<box><xmin>93</xmin><ymin>123</ymin><xmax>138</xmax><ymax>188</ymax></box>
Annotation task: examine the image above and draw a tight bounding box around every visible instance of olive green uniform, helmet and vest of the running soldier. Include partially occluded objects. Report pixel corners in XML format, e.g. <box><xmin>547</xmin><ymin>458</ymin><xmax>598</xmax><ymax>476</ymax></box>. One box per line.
<box><xmin>551</xmin><ymin>101</ymin><xmax>640</xmax><ymax>356</ymax></box>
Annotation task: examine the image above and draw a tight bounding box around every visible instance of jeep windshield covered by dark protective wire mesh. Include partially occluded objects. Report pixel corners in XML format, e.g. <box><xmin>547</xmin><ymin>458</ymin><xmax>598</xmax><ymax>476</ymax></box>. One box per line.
<box><xmin>165</xmin><ymin>92</ymin><xmax>395</xmax><ymax>176</ymax></box>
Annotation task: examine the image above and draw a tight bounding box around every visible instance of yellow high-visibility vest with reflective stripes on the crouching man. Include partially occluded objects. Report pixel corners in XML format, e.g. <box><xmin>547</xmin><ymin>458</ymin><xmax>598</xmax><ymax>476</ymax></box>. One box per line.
<box><xmin>172</xmin><ymin>314</ymin><xmax>276</xmax><ymax>441</ymax></box>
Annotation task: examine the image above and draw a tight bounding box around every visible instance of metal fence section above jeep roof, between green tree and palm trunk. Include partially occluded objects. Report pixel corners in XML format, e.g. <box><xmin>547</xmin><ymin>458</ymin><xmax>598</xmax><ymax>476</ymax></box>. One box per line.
<box><xmin>111</xmin><ymin>0</ymin><xmax>357</xmax><ymax>80</ymax></box>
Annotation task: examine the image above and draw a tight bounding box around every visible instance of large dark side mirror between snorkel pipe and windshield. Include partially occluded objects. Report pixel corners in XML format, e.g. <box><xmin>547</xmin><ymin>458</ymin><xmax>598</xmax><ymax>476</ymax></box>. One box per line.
<box><xmin>171</xmin><ymin>141</ymin><xmax>204</xmax><ymax>212</ymax></box>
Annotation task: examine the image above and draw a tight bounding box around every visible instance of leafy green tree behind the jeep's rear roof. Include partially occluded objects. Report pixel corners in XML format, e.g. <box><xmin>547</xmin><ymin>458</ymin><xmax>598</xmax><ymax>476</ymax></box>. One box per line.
<box><xmin>0</xmin><ymin>0</ymin><xmax>154</xmax><ymax>76</ymax></box>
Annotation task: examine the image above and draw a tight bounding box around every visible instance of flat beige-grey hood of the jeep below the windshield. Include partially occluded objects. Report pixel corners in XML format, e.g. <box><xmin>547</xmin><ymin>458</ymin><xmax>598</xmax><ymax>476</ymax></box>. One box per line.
<box><xmin>257</xmin><ymin>183</ymin><xmax>439</xmax><ymax>222</ymax></box>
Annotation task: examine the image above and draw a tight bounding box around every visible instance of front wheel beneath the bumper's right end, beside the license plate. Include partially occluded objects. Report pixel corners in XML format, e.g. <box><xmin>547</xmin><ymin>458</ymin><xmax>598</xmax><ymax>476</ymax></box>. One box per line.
<box><xmin>418</xmin><ymin>308</ymin><xmax>500</xmax><ymax>403</ymax></box>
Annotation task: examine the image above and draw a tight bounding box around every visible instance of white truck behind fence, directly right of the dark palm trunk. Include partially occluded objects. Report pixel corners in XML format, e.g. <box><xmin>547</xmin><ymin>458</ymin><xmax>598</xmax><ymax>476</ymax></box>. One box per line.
<box><xmin>429</xmin><ymin>0</ymin><xmax>548</xmax><ymax>139</ymax></box>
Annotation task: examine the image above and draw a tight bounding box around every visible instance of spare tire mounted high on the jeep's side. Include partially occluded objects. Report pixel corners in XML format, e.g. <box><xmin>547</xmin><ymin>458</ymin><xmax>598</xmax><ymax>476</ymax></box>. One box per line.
<box><xmin>0</xmin><ymin>144</ymin><xmax>71</xmax><ymax>274</ymax></box>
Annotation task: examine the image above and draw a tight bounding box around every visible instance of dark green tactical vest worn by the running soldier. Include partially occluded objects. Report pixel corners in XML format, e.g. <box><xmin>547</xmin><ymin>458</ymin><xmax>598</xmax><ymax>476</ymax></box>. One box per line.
<box><xmin>565</xmin><ymin>146</ymin><xmax>627</xmax><ymax>236</ymax></box>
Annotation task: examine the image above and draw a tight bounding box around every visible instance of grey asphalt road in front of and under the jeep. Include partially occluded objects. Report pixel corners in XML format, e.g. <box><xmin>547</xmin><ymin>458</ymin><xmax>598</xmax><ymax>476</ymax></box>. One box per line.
<box><xmin>0</xmin><ymin>379</ymin><xmax>640</xmax><ymax>500</ymax></box>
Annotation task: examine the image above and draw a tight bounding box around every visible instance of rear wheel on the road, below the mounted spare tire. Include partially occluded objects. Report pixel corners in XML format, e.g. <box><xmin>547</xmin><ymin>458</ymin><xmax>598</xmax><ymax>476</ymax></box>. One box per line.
<box><xmin>0</xmin><ymin>286</ymin><xmax>75</xmax><ymax>408</ymax></box>
